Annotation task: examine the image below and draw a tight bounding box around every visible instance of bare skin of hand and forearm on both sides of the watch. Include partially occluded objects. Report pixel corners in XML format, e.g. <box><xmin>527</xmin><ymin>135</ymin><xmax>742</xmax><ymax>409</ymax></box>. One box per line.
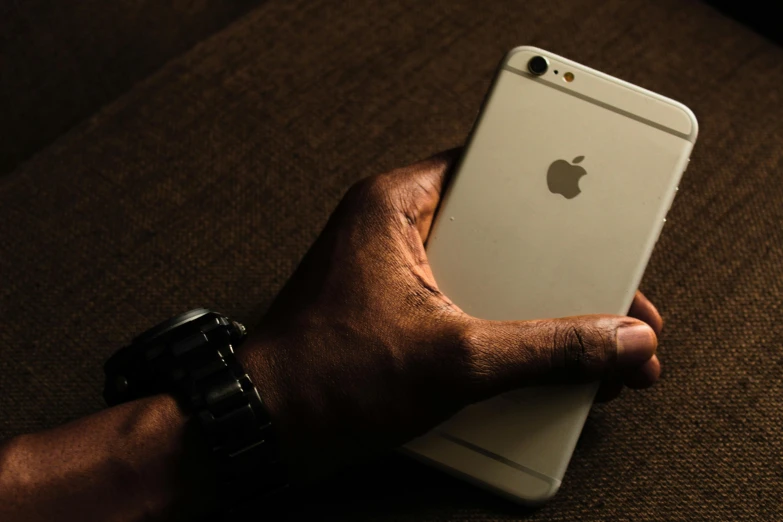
<box><xmin>0</xmin><ymin>152</ymin><xmax>661</xmax><ymax>522</ymax></box>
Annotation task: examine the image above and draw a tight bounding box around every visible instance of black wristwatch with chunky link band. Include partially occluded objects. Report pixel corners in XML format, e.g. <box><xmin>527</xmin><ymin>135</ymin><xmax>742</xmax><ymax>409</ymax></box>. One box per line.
<box><xmin>103</xmin><ymin>308</ymin><xmax>287</xmax><ymax>510</ymax></box>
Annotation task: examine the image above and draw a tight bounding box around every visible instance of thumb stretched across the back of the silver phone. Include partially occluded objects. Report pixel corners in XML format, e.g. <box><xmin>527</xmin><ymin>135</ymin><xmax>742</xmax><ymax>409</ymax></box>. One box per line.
<box><xmin>462</xmin><ymin>315</ymin><xmax>658</xmax><ymax>398</ymax></box>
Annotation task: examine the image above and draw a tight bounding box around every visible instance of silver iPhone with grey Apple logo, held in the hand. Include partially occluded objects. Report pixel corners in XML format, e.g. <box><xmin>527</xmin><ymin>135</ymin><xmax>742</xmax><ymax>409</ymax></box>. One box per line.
<box><xmin>406</xmin><ymin>47</ymin><xmax>697</xmax><ymax>503</ymax></box>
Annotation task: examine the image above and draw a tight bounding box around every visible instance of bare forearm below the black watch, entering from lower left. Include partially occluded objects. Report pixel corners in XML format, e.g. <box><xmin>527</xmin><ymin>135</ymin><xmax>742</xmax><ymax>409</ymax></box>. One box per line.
<box><xmin>0</xmin><ymin>395</ymin><xmax>214</xmax><ymax>522</ymax></box>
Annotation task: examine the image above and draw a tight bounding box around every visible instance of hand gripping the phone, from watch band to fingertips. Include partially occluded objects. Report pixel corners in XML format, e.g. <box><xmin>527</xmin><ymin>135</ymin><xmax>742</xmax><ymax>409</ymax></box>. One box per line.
<box><xmin>239</xmin><ymin>151</ymin><xmax>661</xmax><ymax>483</ymax></box>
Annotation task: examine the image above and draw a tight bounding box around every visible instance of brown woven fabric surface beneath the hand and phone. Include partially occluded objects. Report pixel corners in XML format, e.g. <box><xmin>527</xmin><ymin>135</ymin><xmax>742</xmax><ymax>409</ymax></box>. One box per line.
<box><xmin>0</xmin><ymin>0</ymin><xmax>783</xmax><ymax>521</ymax></box>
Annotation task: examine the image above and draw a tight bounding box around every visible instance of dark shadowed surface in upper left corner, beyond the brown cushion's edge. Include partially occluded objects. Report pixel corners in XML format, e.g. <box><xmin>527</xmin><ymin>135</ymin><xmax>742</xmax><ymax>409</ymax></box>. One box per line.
<box><xmin>0</xmin><ymin>0</ymin><xmax>259</xmax><ymax>175</ymax></box>
